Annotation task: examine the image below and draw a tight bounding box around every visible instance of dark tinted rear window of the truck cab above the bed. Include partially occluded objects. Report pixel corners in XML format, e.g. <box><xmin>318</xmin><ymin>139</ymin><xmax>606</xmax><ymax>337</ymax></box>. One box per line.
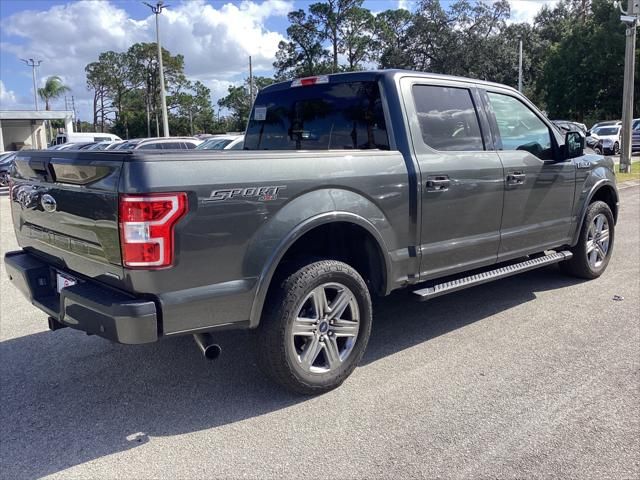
<box><xmin>244</xmin><ymin>82</ymin><xmax>389</xmax><ymax>150</ymax></box>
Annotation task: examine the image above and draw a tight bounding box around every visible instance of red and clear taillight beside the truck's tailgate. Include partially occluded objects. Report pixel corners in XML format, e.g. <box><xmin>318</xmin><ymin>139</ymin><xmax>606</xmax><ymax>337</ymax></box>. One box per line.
<box><xmin>119</xmin><ymin>192</ymin><xmax>188</xmax><ymax>268</ymax></box>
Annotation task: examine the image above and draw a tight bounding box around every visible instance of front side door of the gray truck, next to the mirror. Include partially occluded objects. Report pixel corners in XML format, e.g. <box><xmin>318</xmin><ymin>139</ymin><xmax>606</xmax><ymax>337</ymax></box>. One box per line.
<box><xmin>485</xmin><ymin>91</ymin><xmax>575</xmax><ymax>260</ymax></box>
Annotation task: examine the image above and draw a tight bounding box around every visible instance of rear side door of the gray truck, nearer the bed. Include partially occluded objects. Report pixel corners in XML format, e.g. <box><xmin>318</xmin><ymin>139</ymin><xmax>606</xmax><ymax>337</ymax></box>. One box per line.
<box><xmin>402</xmin><ymin>79</ymin><xmax>504</xmax><ymax>280</ymax></box>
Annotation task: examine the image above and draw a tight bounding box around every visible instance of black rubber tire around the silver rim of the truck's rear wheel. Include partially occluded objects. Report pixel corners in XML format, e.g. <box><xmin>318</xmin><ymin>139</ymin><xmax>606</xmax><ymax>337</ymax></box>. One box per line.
<box><xmin>256</xmin><ymin>260</ymin><xmax>371</xmax><ymax>395</ymax></box>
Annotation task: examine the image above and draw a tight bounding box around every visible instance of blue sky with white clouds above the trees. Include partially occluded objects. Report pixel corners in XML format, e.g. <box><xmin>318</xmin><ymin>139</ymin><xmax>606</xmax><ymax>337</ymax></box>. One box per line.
<box><xmin>0</xmin><ymin>0</ymin><xmax>557</xmax><ymax>121</ymax></box>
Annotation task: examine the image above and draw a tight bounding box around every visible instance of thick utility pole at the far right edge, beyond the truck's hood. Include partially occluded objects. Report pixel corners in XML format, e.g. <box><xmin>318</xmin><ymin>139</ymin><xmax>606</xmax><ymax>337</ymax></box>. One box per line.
<box><xmin>614</xmin><ymin>0</ymin><xmax>640</xmax><ymax>173</ymax></box>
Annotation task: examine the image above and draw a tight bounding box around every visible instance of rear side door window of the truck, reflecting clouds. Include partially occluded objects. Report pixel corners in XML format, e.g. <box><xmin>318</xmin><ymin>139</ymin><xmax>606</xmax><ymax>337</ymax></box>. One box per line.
<box><xmin>413</xmin><ymin>85</ymin><xmax>484</xmax><ymax>152</ymax></box>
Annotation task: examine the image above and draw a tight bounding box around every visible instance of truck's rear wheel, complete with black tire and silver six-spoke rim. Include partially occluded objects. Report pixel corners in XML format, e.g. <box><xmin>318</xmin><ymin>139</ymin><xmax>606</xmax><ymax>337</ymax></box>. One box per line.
<box><xmin>257</xmin><ymin>260</ymin><xmax>371</xmax><ymax>395</ymax></box>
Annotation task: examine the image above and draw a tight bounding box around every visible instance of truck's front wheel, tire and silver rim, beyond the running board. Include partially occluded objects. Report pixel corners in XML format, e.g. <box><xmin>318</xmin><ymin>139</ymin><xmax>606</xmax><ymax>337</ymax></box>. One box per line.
<box><xmin>560</xmin><ymin>201</ymin><xmax>615</xmax><ymax>279</ymax></box>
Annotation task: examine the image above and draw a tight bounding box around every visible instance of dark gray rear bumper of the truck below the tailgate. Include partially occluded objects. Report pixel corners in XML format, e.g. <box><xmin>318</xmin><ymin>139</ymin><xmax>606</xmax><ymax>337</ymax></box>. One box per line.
<box><xmin>4</xmin><ymin>251</ymin><xmax>158</xmax><ymax>344</ymax></box>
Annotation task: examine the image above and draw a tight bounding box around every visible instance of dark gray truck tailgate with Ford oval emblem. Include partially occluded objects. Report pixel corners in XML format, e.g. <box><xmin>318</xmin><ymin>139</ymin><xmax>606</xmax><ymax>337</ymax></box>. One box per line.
<box><xmin>11</xmin><ymin>151</ymin><xmax>124</xmax><ymax>286</ymax></box>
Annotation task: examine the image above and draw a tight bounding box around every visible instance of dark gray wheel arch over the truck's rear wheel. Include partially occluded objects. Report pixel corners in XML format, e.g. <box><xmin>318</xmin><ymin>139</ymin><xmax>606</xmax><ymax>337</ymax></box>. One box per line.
<box><xmin>243</xmin><ymin>188</ymin><xmax>397</xmax><ymax>327</ymax></box>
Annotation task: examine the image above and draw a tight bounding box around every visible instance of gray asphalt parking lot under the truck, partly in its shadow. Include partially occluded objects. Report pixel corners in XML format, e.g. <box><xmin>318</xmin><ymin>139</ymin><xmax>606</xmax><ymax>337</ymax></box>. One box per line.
<box><xmin>0</xmin><ymin>186</ymin><xmax>640</xmax><ymax>479</ymax></box>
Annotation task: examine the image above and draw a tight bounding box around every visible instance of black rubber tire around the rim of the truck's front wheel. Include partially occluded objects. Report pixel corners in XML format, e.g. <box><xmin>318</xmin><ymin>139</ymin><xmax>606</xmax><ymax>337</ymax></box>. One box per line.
<box><xmin>559</xmin><ymin>201</ymin><xmax>615</xmax><ymax>280</ymax></box>
